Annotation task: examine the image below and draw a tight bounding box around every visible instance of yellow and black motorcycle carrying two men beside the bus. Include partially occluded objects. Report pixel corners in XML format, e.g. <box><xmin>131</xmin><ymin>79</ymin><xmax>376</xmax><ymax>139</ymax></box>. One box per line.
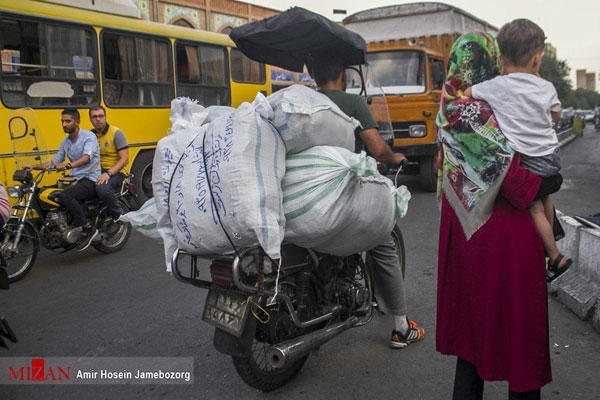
<box><xmin>0</xmin><ymin>168</ymin><xmax>134</xmax><ymax>282</ymax></box>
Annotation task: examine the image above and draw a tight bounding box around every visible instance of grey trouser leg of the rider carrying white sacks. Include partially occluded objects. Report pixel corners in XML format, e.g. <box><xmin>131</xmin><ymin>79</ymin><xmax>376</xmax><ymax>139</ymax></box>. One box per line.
<box><xmin>369</xmin><ymin>235</ymin><xmax>406</xmax><ymax>315</ymax></box>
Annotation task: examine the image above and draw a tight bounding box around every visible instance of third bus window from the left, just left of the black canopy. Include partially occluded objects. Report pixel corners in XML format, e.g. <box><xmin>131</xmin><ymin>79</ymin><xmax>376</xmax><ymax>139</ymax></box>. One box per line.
<box><xmin>175</xmin><ymin>41</ymin><xmax>231</xmax><ymax>106</ymax></box>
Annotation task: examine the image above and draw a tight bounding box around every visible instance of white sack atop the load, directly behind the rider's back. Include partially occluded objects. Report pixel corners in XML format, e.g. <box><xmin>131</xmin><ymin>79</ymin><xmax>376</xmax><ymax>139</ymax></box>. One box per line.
<box><xmin>267</xmin><ymin>85</ymin><xmax>360</xmax><ymax>154</ymax></box>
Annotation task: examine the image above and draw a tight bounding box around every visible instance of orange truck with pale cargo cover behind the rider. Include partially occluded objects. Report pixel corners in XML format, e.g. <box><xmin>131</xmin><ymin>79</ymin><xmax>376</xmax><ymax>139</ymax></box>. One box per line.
<box><xmin>343</xmin><ymin>2</ymin><xmax>498</xmax><ymax>191</ymax></box>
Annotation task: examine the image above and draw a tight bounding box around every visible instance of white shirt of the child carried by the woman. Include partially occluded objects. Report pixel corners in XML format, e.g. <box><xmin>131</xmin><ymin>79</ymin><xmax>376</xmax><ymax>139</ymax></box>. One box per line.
<box><xmin>471</xmin><ymin>72</ymin><xmax>561</xmax><ymax>157</ymax></box>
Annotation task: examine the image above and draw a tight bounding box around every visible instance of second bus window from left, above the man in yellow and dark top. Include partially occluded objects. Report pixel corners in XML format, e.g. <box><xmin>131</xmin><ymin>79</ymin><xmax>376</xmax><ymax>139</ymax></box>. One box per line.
<box><xmin>102</xmin><ymin>33</ymin><xmax>173</xmax><ymax>107</ymax></box>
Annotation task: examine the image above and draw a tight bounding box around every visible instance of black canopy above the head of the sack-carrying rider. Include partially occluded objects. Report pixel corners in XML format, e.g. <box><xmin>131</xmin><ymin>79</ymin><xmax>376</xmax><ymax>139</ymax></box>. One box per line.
<box><xmin>229</xmin><ymin>7</ymin><xmax>367</xmax><ymax>72</ymax></box>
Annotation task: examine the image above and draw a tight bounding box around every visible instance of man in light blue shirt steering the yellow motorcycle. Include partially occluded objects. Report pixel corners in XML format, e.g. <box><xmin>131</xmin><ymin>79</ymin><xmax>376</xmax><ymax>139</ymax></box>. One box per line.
<box><xmin>33</xmin><ymin>108</ymin><xmax>100</xmax><ymax>251</ymax></box>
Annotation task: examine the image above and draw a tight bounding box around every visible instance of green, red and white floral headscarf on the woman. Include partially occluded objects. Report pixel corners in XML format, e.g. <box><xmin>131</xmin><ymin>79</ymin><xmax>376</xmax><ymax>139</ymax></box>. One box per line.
<box><xmin>436</xmin><ymin>32</ymin><xmax>513</xmax><ymax>239</ymax></box>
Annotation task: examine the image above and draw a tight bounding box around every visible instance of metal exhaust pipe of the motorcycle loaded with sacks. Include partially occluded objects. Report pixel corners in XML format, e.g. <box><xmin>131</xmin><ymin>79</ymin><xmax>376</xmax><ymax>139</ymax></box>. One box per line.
<box><xmin>267</xmin><ymin>317</ymin><xmax>358</xmax><ymax>368</ymax></box>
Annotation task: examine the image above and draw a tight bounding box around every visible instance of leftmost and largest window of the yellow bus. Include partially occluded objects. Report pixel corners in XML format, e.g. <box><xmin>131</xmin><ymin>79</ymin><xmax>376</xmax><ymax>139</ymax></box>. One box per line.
<box><xmin>0</xmin><ymin>17</ymin><xmax>99</xmax><ymax>108</ymax></box>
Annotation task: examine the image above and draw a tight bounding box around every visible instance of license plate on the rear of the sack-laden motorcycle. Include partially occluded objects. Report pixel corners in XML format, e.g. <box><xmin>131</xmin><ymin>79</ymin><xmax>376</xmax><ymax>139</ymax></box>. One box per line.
<box><xmin>202</xmin><ymin>289</ymin><xmax>249</xmax><ymax>337</ymax></box>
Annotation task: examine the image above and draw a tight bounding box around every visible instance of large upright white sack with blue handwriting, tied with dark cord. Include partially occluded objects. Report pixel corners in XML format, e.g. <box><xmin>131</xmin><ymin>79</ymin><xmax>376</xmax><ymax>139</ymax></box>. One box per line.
<box><xmin>168</xmin><ymin>94</ymin><xmax>285</xmax><ymax>258</ymax></box>
